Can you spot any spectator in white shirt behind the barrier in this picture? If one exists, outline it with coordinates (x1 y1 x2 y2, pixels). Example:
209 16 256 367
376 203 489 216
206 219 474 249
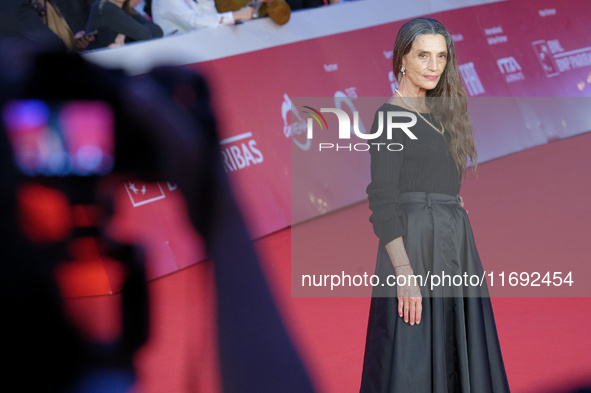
152 0 254 34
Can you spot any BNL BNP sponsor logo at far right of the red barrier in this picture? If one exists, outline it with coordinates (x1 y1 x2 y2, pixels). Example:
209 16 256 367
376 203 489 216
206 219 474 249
532 39 591 78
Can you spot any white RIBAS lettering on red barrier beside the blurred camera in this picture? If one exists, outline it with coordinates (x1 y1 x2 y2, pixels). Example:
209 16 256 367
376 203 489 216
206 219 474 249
220 132 264 172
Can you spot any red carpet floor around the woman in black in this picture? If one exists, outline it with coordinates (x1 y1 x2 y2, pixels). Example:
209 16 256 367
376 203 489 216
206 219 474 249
65 133 591 393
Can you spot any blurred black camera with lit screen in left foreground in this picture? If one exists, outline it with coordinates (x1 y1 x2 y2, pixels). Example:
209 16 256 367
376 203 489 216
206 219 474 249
0 48 190 392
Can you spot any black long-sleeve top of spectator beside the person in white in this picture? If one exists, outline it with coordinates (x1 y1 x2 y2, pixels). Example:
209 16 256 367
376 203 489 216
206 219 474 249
86 1 163 49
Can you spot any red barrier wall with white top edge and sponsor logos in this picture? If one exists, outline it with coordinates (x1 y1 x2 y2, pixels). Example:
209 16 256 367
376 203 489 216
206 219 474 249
72 0 591 295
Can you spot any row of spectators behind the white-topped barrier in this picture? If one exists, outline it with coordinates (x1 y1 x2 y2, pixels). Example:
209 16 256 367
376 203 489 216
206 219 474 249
0 0 350 52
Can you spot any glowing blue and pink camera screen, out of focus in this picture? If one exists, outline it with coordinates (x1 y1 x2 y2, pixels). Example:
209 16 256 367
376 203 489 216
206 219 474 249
2 100 114 176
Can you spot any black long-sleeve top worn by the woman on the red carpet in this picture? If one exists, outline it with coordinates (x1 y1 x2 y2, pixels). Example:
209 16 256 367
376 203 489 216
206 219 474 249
366 104 461 245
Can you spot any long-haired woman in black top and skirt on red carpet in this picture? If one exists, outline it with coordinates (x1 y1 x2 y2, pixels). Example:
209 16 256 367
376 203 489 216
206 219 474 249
360 18 509 393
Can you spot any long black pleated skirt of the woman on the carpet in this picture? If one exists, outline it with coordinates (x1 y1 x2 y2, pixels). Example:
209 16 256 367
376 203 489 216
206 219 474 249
360 192 509 393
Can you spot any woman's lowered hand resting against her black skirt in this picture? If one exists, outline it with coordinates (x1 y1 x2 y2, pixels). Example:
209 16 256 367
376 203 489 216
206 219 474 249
394 265 423 326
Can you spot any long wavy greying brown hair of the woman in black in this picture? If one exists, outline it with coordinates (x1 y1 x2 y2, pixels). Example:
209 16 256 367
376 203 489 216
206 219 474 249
392 18 478 177
